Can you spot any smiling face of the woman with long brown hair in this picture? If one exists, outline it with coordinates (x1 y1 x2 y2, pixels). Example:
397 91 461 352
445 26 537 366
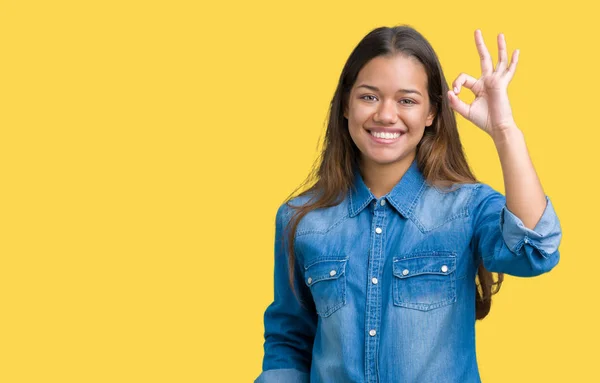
344 55 435 171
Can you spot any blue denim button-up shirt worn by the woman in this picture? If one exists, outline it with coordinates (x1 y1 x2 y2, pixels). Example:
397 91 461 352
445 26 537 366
255 162 562 383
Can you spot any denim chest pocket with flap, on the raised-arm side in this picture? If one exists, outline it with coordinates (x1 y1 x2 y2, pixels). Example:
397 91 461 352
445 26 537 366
392 251 456 311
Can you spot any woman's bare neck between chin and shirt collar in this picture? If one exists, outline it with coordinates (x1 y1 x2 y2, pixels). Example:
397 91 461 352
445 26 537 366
359 154 415 198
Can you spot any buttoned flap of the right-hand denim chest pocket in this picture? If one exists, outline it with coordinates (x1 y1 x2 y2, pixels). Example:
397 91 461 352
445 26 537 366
393 252 456 278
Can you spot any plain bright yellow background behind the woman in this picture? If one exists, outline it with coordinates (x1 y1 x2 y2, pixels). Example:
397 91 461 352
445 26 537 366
0 0 600 383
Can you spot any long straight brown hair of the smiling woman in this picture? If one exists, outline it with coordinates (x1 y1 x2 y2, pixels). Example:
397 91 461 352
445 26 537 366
283 25 504 319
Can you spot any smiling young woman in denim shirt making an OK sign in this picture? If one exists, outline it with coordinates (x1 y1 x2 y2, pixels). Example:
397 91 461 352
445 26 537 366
256 26 561 383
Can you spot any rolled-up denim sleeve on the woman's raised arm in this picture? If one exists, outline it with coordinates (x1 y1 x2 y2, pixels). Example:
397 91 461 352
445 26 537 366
472 185 562 277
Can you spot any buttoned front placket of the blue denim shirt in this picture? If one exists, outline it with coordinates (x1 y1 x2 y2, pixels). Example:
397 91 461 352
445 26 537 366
365 198 387 383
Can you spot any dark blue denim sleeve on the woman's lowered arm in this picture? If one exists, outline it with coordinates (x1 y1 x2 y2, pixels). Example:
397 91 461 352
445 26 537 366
255 204 317 383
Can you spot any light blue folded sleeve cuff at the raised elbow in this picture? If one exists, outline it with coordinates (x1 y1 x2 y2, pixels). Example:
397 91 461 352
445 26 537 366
500 196 562 258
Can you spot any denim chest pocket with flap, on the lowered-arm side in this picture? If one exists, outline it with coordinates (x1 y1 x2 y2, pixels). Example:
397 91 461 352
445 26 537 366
304 258 348 317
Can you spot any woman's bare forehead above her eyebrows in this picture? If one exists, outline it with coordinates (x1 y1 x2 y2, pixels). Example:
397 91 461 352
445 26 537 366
354 54 427 94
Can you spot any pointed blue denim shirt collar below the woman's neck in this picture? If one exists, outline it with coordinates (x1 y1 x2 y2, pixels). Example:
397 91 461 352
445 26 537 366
348 159 426 217
